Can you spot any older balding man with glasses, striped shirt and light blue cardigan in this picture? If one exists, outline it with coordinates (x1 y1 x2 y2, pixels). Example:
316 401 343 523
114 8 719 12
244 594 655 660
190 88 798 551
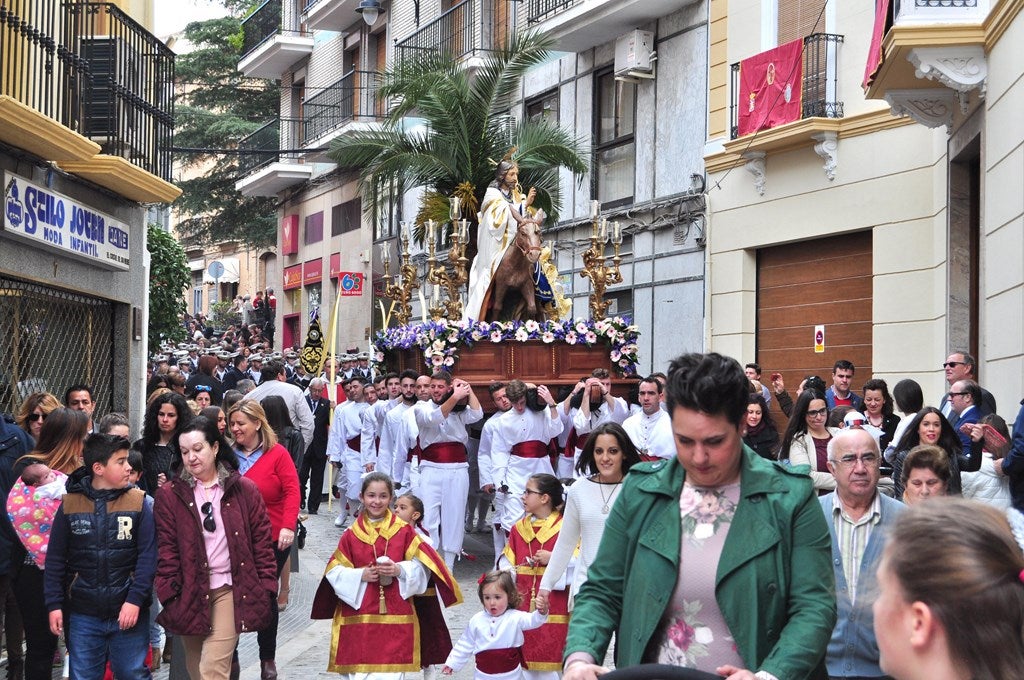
818 428 903 679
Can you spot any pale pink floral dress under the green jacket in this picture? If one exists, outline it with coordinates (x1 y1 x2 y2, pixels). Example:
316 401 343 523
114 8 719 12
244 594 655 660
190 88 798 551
645 482 744 673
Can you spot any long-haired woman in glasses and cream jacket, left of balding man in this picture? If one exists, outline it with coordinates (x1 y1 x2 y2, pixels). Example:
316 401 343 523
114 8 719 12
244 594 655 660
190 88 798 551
778 389 839 494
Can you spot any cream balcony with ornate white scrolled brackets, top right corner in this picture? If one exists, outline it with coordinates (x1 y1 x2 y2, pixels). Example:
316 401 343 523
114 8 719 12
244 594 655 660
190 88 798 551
863 0 991 127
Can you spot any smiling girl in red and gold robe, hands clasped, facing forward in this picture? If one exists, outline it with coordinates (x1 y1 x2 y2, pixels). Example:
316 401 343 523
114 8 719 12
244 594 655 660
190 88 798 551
311 472 462 680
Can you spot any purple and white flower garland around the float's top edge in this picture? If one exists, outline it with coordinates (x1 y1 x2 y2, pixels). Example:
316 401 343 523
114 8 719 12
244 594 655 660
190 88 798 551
374 316 640 375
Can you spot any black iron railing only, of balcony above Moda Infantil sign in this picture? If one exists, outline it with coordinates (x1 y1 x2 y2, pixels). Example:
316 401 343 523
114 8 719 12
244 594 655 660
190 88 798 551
0 0 174 180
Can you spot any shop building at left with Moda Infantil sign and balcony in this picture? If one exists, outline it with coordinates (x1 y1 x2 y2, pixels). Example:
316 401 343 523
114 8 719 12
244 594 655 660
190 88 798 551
0 0 179 425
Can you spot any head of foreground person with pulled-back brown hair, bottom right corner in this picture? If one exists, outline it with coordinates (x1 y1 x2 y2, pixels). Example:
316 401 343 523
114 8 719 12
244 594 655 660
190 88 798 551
873 499 1024 680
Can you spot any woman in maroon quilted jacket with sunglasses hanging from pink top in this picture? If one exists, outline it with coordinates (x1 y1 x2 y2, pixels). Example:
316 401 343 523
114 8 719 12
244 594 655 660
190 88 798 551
154 417 278 680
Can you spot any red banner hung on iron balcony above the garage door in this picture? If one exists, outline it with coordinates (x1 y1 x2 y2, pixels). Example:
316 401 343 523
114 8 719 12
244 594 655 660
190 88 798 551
737 39 804 136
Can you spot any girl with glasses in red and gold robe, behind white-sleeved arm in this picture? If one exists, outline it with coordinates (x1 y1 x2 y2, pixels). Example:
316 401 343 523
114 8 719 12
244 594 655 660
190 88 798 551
499 473 571 680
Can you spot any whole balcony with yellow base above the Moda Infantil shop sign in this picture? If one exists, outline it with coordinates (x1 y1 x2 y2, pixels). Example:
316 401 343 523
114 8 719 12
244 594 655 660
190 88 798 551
0 0 178 202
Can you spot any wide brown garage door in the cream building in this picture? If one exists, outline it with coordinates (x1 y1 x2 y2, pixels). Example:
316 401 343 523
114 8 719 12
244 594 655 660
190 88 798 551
757 231 871 427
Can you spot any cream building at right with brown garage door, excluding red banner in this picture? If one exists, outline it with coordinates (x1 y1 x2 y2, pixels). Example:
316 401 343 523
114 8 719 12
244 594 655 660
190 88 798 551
705 0 1024 416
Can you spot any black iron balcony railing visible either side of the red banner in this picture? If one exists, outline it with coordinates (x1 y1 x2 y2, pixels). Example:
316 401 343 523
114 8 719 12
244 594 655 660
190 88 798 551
729 33 843 139
